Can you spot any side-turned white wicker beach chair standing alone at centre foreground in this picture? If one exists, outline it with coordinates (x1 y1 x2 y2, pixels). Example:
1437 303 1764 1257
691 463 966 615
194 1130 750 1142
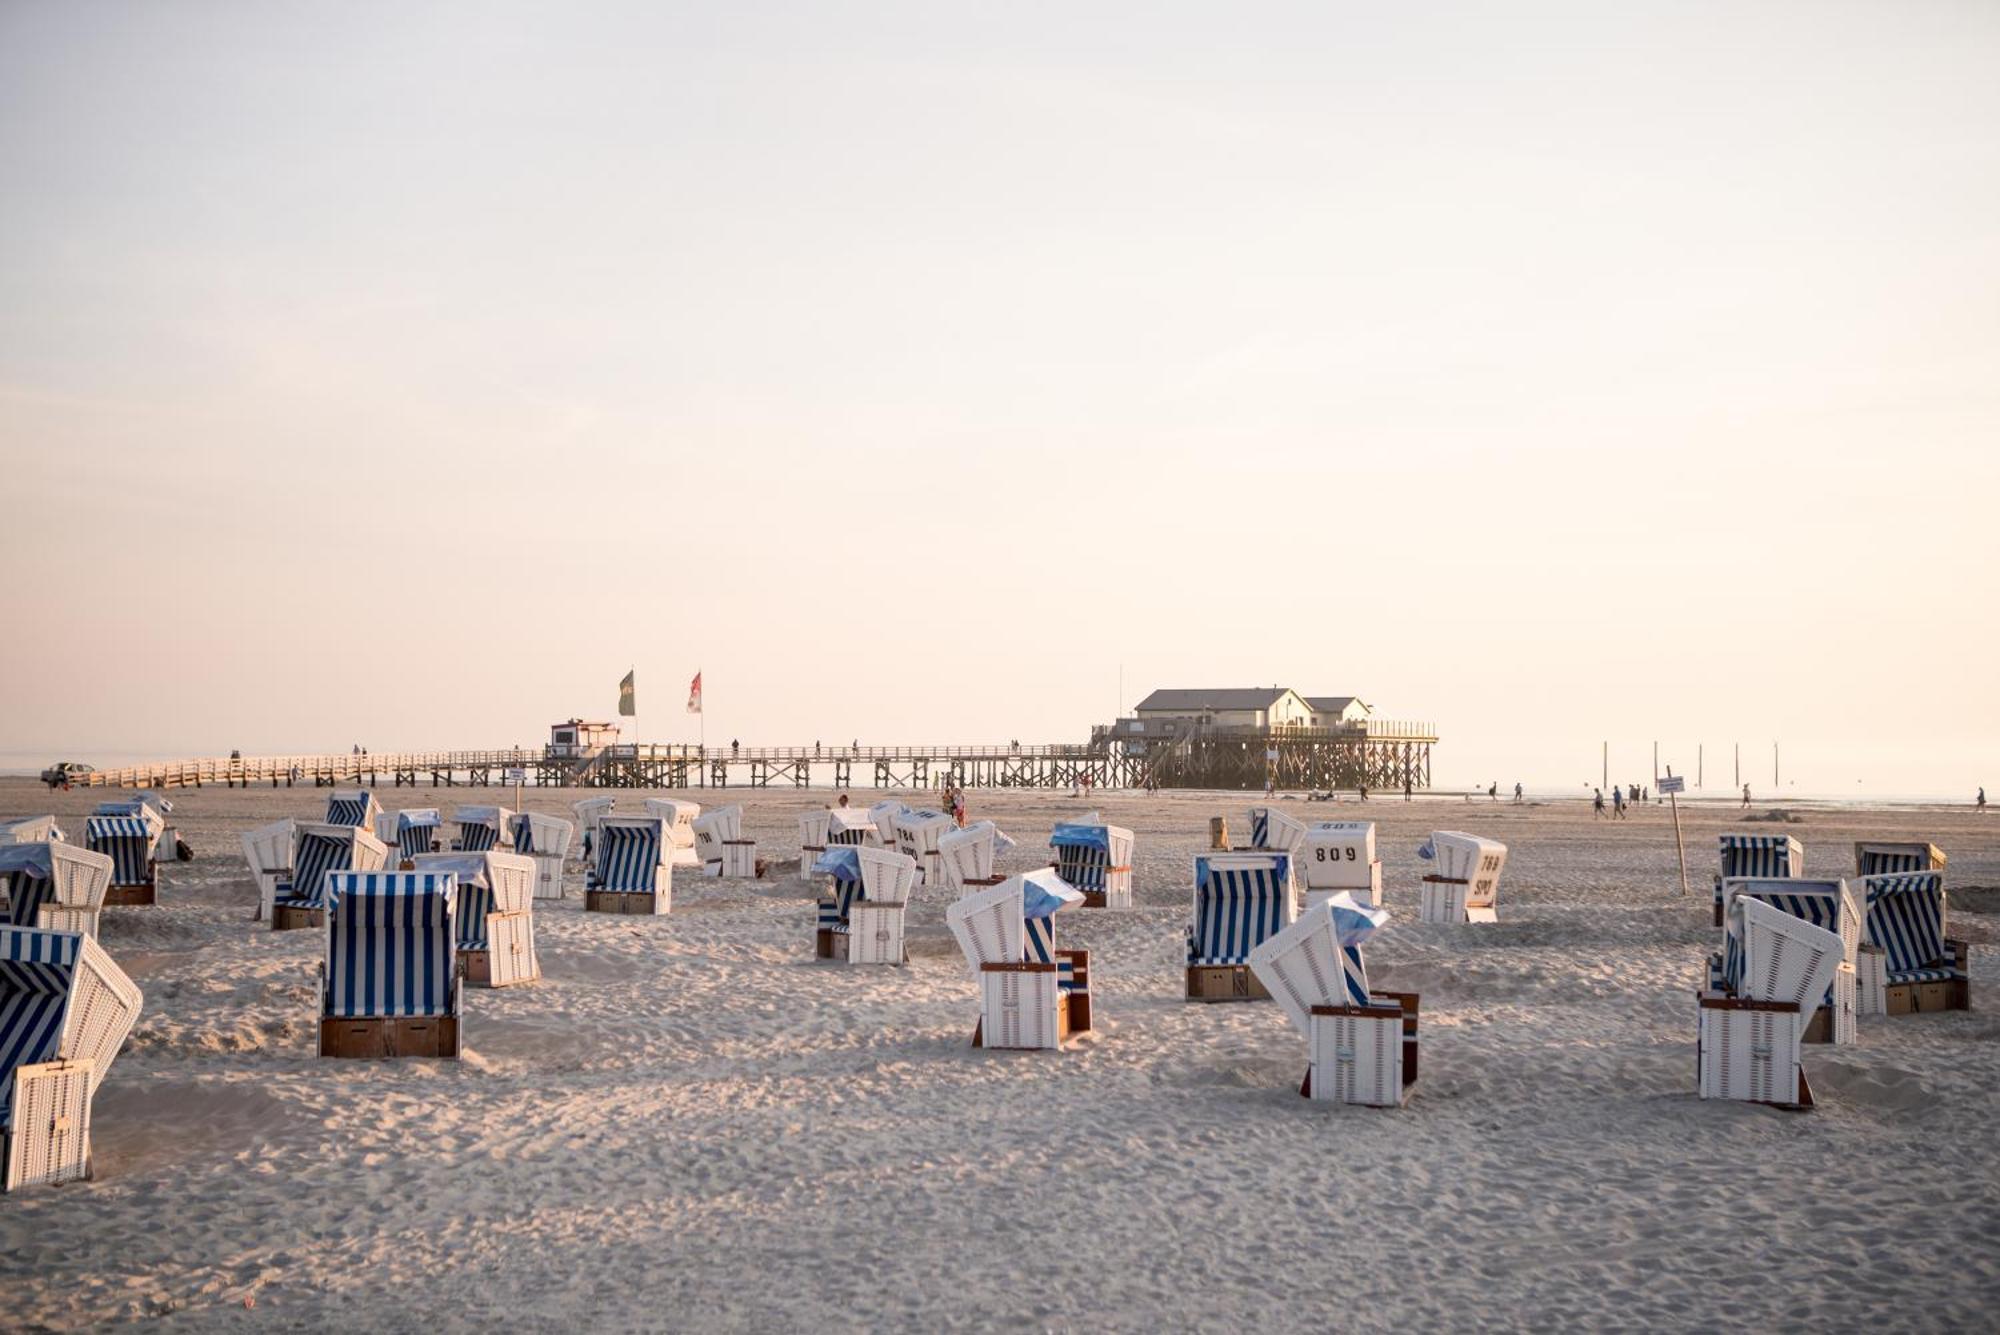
944 869 1090 1049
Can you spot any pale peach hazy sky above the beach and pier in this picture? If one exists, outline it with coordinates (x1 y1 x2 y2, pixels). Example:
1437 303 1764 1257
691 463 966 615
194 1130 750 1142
0 0 2000 795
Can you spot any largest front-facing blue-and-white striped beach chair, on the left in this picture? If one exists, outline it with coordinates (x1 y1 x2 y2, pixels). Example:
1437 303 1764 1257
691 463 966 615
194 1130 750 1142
320 871 460 1057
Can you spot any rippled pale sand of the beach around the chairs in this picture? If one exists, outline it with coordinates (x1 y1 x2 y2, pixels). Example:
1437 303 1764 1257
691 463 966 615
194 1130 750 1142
0 779 2000 1331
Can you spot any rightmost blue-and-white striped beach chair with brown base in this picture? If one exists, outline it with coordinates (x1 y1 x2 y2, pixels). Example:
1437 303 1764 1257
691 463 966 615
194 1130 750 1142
1858 871 1972 1015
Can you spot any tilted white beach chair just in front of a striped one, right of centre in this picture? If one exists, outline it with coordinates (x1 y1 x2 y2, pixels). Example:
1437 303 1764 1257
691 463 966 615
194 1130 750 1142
1250 889 1420 1107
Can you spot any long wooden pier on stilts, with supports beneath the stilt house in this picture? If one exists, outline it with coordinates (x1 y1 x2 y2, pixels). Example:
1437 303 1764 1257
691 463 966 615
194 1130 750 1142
74 729 1436 789
